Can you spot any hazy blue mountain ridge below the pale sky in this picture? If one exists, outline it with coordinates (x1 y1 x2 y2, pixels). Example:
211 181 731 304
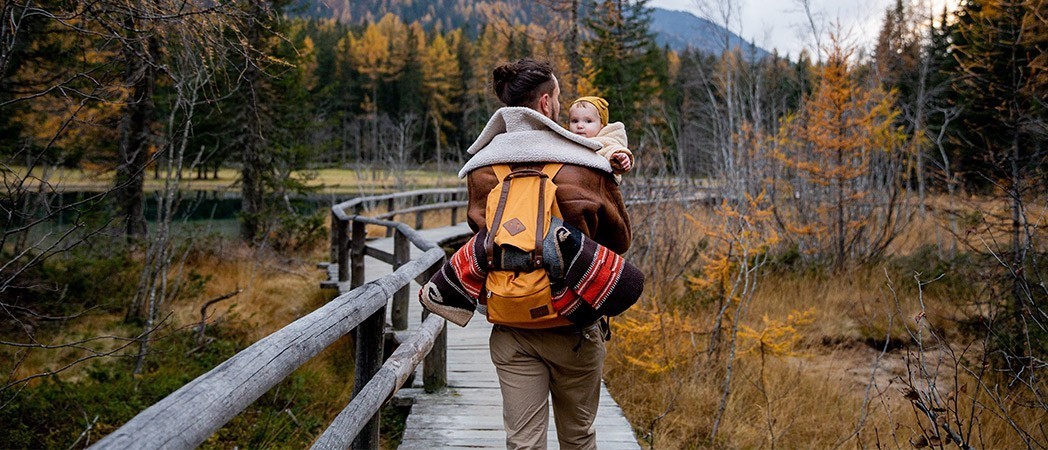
651 7 771 60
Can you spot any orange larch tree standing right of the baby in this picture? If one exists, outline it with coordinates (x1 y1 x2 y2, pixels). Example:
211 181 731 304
773 39 904 269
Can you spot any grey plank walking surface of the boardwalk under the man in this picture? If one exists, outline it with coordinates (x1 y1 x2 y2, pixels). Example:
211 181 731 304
354 223 640 450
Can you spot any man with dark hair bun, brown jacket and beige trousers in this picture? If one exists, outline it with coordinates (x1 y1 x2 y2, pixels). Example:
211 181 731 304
459 59 631 449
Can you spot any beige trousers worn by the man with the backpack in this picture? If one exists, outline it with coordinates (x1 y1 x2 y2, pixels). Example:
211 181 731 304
489 324 605 450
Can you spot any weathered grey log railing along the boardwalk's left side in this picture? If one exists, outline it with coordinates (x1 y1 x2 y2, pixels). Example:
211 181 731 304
91 189 465 449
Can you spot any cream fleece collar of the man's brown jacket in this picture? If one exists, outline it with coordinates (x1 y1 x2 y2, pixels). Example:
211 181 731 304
459 106 611 178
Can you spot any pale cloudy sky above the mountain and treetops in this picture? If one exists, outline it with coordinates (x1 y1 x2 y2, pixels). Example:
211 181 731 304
648 0 956 59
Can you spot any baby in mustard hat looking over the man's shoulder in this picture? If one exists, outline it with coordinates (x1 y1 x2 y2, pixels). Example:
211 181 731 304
568 97 633 183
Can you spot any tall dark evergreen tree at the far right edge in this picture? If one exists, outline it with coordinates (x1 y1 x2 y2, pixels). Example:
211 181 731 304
953 0 1048 369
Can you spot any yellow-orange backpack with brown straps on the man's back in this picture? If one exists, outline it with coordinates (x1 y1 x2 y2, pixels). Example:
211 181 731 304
480 164 571 328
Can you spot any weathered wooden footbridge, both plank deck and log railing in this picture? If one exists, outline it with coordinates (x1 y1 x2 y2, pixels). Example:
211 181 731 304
91 182 704 449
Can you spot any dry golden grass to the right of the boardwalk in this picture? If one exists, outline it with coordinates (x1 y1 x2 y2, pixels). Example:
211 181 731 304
606 191 1048 449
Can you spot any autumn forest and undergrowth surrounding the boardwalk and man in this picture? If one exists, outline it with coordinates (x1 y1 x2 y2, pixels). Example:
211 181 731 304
0 0 1048 449
